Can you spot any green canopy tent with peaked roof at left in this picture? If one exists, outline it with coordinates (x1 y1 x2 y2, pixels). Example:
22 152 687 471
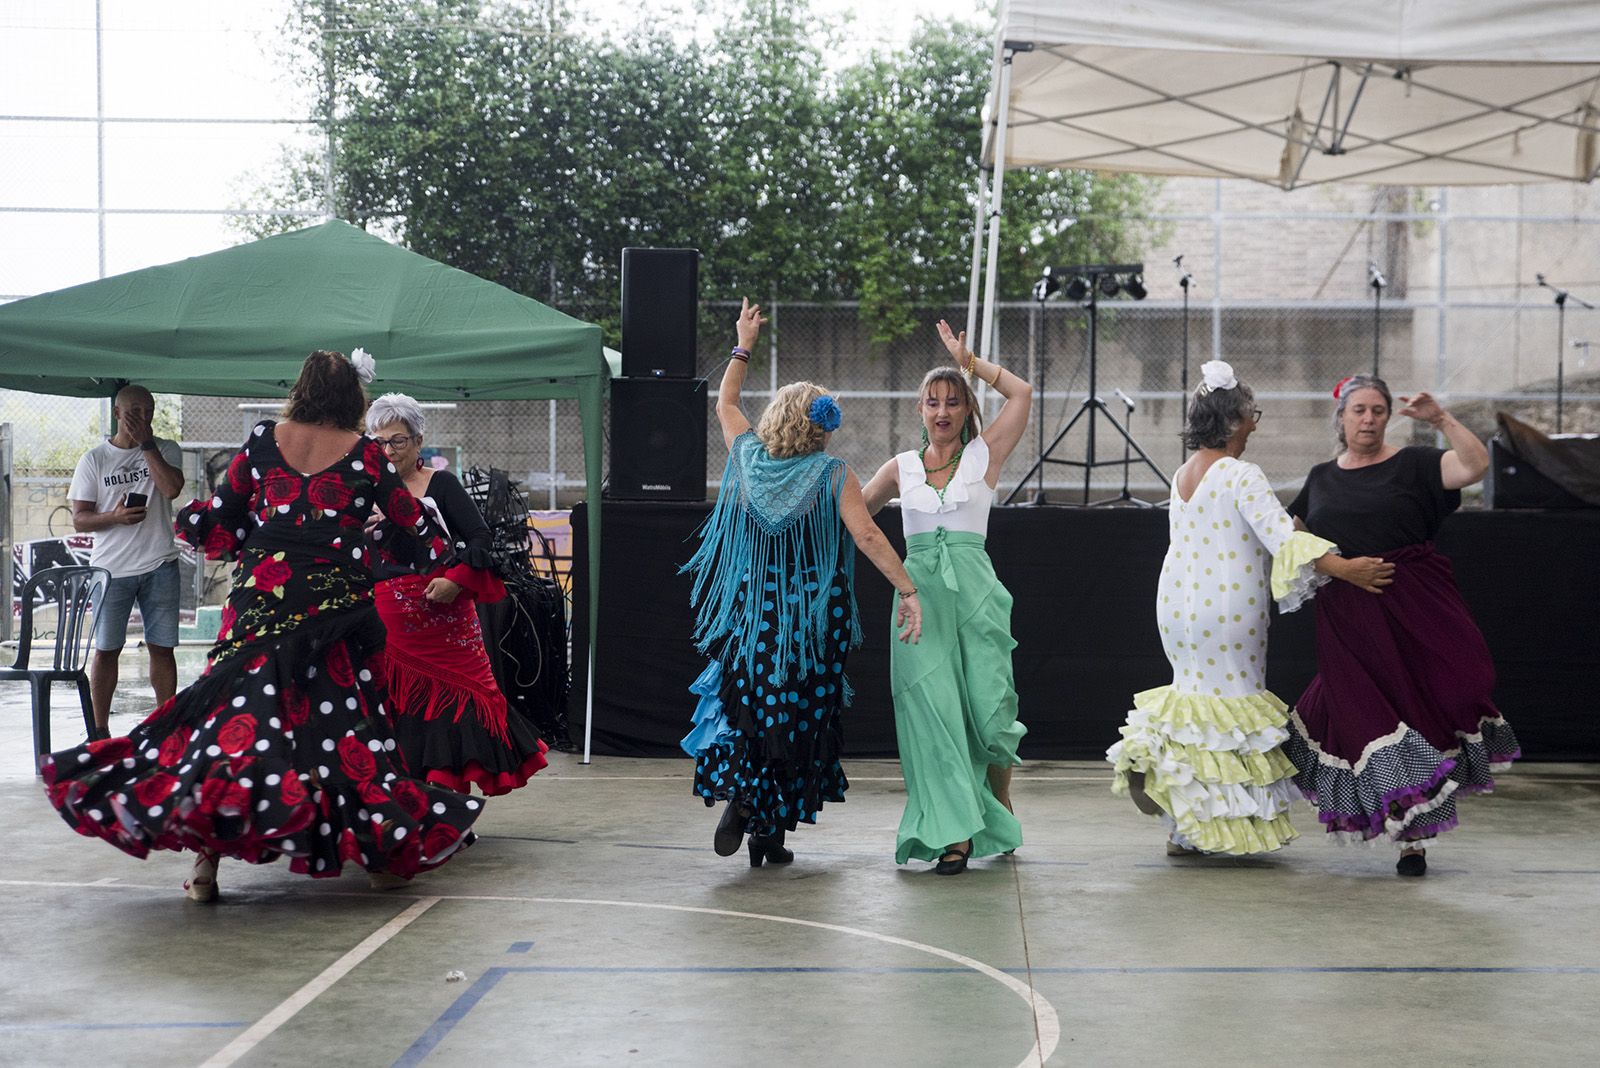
0 222 611 761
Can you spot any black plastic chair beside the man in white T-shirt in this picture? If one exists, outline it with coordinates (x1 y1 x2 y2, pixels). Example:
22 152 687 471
0 564 110 756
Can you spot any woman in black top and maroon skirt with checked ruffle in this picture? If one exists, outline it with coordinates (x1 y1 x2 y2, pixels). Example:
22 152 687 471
1283 374 1522 876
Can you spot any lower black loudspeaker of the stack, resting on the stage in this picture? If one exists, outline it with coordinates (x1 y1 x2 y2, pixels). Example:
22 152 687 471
606 379 706 500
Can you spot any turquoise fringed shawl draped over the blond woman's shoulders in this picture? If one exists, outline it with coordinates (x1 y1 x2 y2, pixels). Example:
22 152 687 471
682 430 861 678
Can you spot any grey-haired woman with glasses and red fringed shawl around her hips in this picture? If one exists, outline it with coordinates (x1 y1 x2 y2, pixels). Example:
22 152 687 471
366 393 546 795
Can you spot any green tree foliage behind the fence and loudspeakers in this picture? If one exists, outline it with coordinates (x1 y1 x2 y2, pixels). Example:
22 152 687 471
254 0 1150 341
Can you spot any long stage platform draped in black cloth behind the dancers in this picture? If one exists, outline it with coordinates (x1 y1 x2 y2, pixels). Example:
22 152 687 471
571 500 1600 761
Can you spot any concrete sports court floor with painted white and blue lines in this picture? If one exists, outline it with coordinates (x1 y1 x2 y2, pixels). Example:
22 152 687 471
0 651 1600 1068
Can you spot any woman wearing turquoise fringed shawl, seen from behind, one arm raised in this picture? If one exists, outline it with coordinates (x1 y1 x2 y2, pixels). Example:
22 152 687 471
683 299 922 868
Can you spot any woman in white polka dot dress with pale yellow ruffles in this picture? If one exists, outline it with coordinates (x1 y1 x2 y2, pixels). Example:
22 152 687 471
1106 360 1394 855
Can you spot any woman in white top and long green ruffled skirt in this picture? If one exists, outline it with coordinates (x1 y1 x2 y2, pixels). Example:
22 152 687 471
862 320 1034 875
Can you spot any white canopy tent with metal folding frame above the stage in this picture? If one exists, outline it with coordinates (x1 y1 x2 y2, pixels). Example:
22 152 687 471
968 0 1600 352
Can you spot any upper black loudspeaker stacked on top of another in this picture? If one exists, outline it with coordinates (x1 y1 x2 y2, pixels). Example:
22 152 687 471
622 248 699 379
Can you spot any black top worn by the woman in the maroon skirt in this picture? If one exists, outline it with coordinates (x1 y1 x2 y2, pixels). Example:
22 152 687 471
1290 444 1461 556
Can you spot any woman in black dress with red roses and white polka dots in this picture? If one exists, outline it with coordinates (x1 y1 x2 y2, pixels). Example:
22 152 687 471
43 350 483 900
